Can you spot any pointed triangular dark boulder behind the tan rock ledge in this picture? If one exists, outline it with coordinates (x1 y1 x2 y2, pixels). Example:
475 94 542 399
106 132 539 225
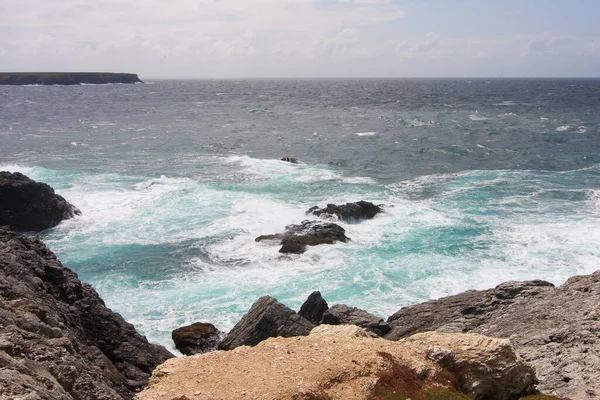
219 296 314 350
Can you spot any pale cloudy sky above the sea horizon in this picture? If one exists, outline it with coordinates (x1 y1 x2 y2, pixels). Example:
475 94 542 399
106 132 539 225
0 0 600 79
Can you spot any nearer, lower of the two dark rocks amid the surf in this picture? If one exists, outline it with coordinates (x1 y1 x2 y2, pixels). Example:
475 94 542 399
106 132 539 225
255 221 350 254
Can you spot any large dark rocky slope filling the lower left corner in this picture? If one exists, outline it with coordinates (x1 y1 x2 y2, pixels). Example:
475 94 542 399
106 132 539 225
0 230 173 400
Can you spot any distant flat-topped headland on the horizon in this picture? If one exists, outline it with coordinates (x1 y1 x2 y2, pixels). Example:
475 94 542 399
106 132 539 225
0 72 142 85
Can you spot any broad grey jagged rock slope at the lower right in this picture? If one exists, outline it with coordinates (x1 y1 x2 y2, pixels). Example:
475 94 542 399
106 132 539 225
386 271 600 400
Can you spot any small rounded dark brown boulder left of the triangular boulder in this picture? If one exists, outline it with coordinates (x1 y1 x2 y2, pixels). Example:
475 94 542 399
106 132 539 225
171 322 221 356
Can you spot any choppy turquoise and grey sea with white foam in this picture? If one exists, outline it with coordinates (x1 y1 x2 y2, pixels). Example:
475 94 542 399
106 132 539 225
0 79 600 349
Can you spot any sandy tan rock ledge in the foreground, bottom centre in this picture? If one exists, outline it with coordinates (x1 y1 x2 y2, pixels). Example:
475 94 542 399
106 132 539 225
136 325 535 400
